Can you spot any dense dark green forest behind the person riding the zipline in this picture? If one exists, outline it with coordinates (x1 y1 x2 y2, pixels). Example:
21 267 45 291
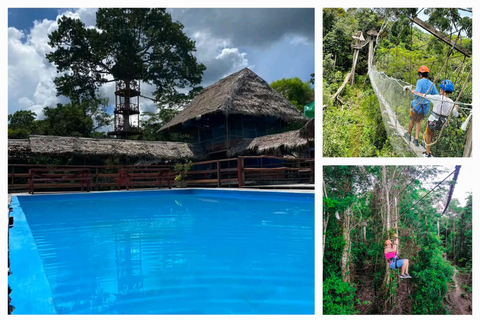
322 166 472 315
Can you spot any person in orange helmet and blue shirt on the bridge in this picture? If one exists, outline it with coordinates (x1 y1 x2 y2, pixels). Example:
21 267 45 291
405 66 438 147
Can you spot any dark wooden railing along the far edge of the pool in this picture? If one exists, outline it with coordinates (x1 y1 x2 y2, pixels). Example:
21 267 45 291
8 156 315 193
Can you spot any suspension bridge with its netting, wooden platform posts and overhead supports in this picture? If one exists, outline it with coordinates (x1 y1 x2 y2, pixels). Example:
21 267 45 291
338 18 472 157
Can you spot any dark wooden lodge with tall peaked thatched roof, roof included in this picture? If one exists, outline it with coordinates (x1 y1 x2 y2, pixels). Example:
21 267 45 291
160 68 308 159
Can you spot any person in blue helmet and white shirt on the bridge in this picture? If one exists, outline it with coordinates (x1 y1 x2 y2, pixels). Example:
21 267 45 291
410 79 458 158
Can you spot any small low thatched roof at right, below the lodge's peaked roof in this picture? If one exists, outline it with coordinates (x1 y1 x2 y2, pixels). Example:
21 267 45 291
227 129 309 157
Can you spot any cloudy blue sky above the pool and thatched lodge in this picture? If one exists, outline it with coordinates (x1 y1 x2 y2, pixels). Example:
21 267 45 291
8 8 315 119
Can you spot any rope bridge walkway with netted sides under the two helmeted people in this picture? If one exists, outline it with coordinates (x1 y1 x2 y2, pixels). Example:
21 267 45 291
368 32 472 157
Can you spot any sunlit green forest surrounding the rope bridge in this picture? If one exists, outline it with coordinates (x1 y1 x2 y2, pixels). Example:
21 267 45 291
322 8 472 157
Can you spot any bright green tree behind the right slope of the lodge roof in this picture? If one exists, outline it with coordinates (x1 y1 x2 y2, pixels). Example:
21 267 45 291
270 77 315 112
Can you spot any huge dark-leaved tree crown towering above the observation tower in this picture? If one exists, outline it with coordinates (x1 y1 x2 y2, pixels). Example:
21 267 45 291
46 8 205 110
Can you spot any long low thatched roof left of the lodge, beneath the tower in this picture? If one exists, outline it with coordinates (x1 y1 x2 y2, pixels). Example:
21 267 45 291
8 136 207 160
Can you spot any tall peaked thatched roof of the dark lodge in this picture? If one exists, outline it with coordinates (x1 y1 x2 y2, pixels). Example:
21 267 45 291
160 68 307 130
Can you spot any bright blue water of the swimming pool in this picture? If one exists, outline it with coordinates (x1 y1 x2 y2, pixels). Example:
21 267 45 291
9 190 314 314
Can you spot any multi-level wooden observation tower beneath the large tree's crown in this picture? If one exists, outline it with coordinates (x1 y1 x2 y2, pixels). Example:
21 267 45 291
108 80 141 139
